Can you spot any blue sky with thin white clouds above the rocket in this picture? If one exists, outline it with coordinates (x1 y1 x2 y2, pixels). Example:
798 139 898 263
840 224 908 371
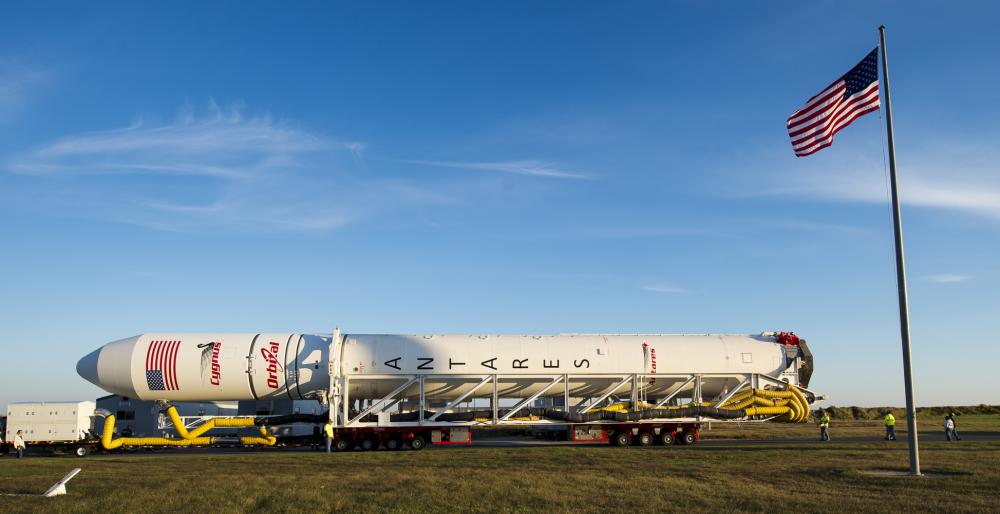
0 2 1000 405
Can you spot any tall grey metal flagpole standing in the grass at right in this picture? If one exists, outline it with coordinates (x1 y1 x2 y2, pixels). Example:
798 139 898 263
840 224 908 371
878 25 920 475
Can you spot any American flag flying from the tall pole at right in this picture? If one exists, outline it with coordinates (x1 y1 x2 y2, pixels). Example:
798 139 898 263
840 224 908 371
788 48 879 157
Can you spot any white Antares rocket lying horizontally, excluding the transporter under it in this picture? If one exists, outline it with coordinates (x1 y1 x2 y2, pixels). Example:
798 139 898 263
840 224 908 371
77 333 789 401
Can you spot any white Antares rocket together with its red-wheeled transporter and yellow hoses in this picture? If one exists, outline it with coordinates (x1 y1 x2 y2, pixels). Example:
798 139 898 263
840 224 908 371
77 330 817 449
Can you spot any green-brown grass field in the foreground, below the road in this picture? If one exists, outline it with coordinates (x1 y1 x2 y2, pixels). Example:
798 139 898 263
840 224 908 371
0 434 1000 513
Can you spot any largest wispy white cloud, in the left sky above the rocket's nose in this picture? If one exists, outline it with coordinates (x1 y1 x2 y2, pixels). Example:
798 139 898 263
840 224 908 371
0 102 449 231
